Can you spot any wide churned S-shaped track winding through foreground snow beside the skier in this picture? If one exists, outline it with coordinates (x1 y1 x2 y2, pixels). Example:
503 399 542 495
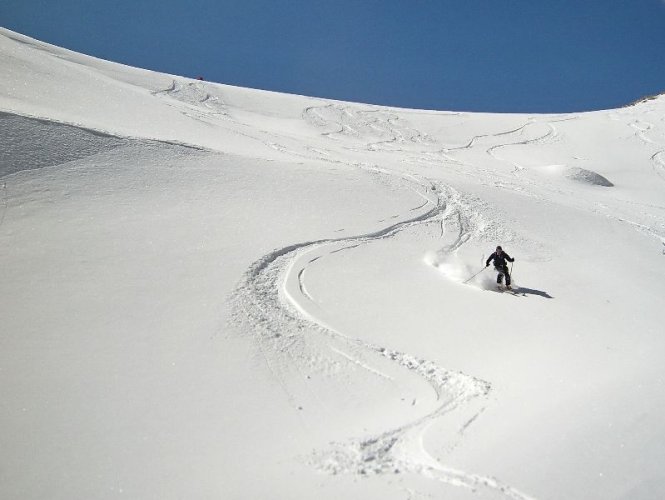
230 172 530 500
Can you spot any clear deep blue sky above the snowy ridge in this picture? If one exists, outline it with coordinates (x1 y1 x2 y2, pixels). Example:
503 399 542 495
0 0 665 112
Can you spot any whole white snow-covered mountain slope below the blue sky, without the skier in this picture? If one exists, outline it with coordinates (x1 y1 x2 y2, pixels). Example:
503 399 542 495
0 30 665 499
